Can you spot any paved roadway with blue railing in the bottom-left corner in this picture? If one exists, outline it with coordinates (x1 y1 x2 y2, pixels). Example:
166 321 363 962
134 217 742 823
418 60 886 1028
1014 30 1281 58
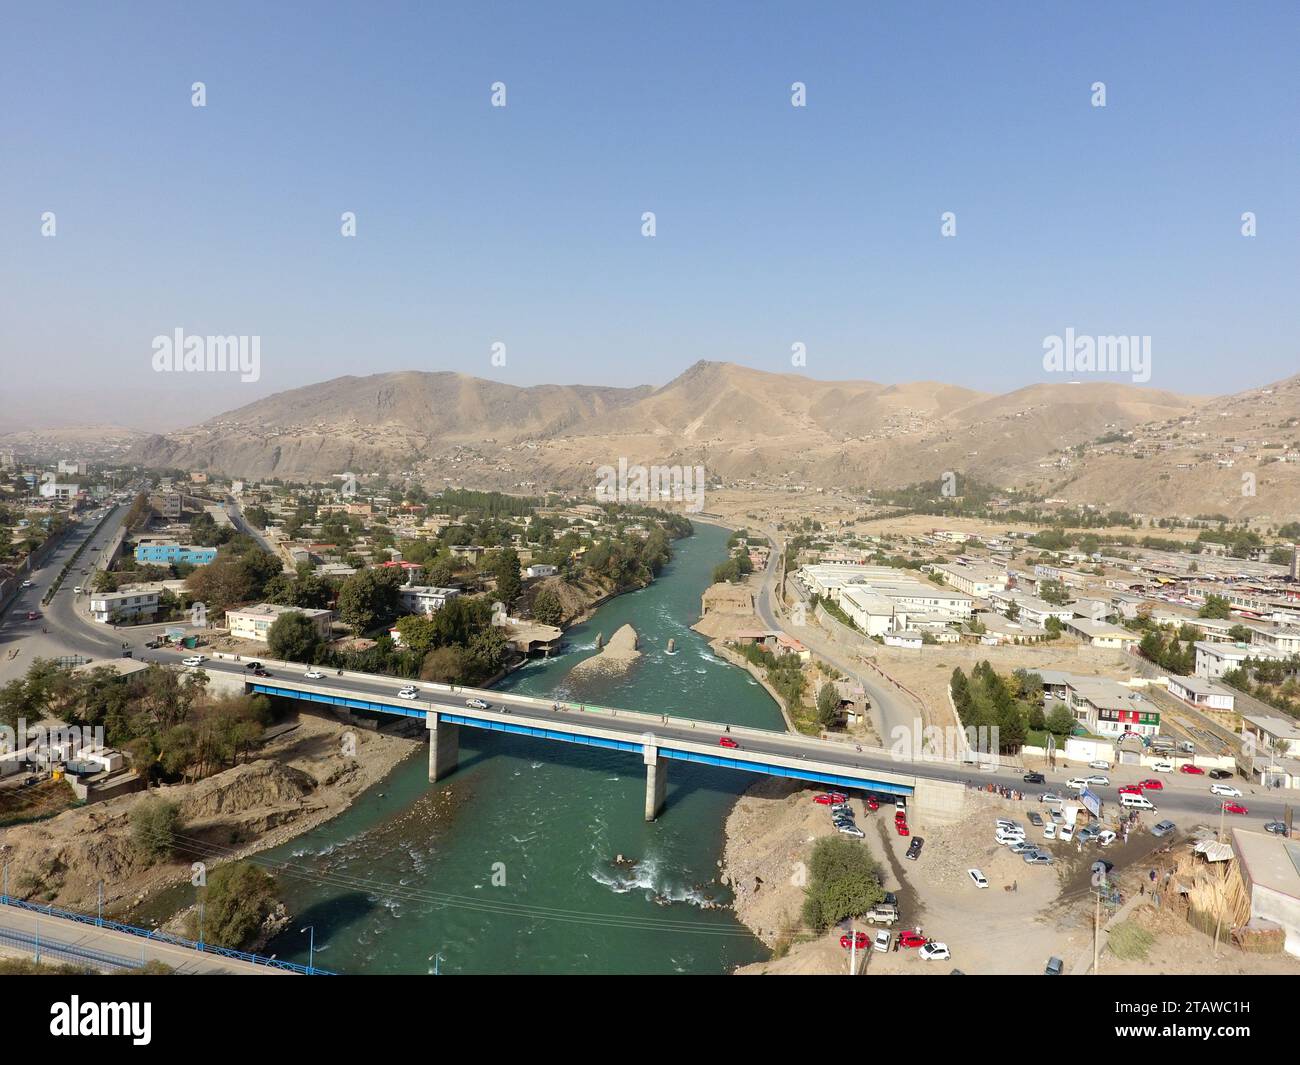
0 905 284 977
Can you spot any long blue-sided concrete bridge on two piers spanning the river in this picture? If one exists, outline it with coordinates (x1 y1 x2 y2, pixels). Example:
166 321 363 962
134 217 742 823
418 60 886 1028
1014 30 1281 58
169 654 972 821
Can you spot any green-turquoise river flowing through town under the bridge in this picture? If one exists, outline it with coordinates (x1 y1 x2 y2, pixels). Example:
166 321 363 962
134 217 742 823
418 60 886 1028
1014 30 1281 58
263 523 783 974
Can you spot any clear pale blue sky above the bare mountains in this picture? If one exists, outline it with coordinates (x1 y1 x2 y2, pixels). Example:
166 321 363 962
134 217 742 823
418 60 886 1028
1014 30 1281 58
0 1 1300 428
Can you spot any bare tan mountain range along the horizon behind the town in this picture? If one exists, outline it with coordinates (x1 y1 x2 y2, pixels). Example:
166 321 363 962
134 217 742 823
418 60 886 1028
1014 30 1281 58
133 362 1300 514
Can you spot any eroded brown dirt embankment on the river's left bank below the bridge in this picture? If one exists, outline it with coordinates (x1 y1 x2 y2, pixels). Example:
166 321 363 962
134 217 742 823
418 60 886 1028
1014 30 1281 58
0 715 419 912
